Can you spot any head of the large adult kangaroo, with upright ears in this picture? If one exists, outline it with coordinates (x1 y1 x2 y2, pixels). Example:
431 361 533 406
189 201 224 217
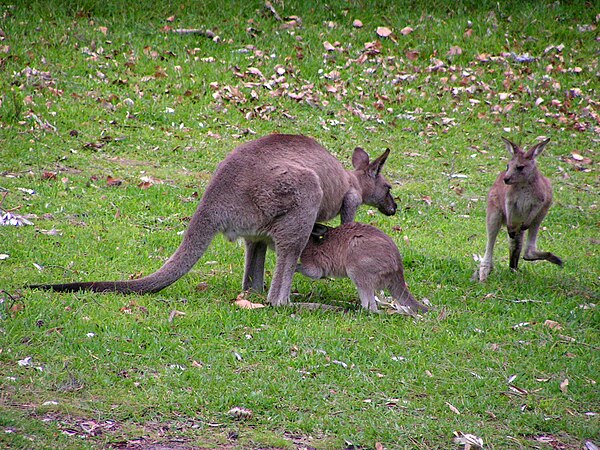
352 147 397 216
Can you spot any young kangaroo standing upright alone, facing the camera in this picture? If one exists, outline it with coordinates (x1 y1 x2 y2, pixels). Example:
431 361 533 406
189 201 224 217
479 138 562 281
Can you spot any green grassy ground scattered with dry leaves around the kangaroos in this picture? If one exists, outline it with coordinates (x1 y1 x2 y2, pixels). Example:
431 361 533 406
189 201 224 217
0 0 600 449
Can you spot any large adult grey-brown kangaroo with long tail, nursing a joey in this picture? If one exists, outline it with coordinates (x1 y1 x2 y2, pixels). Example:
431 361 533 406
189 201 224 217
31 134 396 306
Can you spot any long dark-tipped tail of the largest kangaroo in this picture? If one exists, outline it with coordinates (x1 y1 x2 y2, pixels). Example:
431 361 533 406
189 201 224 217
29 212 218 294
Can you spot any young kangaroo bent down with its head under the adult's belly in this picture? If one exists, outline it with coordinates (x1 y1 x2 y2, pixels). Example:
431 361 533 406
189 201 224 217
298 222 428 312
